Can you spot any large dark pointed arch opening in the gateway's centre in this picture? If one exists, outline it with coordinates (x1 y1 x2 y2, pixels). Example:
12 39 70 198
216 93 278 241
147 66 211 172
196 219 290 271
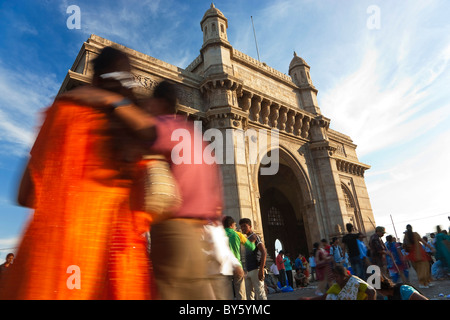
256 146 318 259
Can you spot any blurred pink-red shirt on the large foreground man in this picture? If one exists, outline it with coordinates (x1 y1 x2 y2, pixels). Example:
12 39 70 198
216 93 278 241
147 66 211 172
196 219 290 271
151 115 223 219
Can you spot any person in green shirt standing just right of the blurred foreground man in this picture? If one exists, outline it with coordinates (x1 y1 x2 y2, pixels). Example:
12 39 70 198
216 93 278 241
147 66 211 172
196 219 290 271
222 216 256 300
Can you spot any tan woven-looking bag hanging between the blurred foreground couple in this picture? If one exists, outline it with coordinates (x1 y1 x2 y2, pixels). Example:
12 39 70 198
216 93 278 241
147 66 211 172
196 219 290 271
130 155 182 222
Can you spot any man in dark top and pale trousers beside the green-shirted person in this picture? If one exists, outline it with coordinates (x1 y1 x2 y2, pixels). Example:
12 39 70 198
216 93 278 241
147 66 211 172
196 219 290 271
239 218 267 300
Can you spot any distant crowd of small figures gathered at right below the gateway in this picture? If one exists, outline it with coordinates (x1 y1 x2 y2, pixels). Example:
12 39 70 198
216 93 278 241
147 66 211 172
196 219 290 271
262 223 450 300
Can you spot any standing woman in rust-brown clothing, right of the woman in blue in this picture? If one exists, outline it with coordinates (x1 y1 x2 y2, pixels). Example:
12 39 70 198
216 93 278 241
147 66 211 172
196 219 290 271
403 224 431 288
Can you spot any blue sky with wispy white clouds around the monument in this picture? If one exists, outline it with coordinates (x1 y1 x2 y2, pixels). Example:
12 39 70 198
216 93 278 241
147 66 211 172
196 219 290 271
0 0 450 258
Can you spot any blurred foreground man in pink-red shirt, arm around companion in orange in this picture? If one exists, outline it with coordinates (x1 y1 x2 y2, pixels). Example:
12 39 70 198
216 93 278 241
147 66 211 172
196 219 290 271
74 80 223 300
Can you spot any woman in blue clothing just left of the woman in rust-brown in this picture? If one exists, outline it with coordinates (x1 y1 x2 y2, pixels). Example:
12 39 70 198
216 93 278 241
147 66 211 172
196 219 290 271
386 235 409 283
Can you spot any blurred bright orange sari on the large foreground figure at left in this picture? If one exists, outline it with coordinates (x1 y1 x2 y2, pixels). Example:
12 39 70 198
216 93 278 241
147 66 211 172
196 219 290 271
0 99 155 300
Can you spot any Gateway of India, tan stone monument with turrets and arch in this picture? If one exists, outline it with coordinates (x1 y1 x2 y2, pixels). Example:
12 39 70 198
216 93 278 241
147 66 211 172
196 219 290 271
60 4 375 257
